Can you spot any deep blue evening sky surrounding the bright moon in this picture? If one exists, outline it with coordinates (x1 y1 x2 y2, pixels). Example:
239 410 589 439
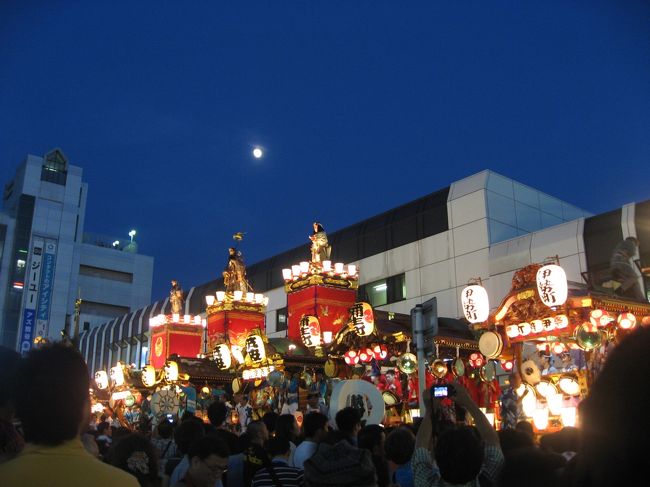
0 0 650 299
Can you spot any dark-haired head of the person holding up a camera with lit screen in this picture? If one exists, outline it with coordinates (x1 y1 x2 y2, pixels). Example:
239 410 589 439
435 426 483 484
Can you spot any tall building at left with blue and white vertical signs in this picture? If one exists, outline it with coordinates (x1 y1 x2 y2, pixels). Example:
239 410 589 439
0 149 153 351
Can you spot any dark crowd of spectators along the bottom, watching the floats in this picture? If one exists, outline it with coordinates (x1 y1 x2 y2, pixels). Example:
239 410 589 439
0 328 650 487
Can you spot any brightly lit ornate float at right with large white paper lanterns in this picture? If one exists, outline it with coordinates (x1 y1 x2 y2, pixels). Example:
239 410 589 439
461 258 650 433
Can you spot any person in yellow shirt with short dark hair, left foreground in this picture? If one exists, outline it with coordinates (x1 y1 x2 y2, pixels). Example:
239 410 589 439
0 344 139 487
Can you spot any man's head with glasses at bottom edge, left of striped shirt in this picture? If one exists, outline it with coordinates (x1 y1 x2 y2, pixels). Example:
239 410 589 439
188 436 230 487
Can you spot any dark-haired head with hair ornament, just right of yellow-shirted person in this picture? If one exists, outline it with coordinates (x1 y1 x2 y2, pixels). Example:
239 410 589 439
108 433 158 487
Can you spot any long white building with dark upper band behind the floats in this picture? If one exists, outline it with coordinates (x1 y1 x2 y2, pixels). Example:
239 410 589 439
81 171 650 370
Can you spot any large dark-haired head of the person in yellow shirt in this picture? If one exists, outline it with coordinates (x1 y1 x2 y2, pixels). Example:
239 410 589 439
15 344 90 446
